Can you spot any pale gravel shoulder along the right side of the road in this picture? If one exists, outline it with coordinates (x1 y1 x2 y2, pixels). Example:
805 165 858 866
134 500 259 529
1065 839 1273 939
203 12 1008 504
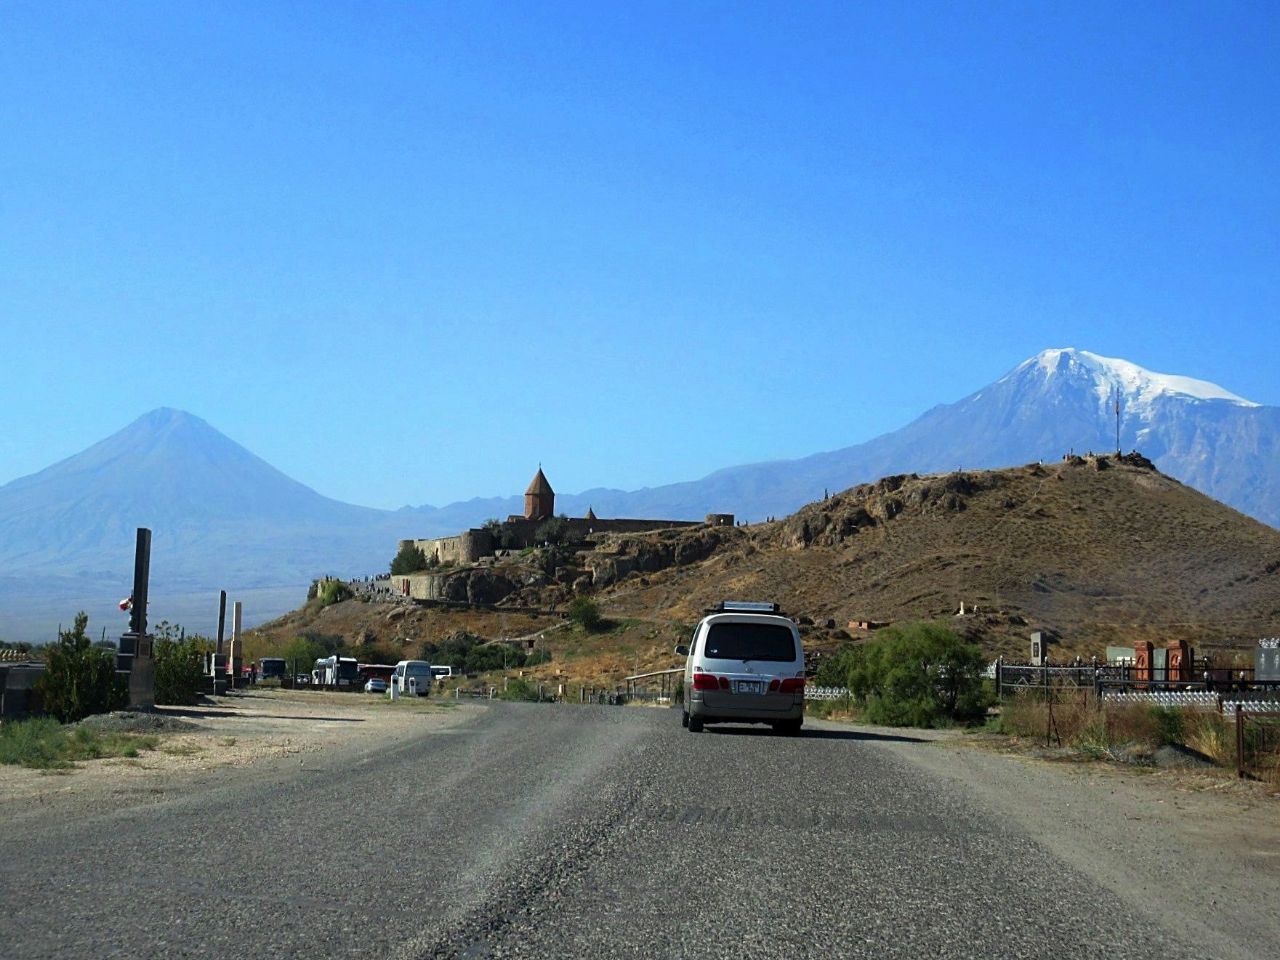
812 721 1280 960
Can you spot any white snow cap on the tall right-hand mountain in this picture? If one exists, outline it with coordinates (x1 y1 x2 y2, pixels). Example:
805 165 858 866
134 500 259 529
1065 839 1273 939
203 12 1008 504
1005 347 1260 407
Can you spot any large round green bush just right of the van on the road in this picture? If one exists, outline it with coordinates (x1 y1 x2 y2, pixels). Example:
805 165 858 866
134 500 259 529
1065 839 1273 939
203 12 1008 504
826 623 989 727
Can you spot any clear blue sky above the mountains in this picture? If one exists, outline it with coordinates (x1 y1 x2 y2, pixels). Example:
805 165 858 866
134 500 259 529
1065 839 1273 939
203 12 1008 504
0 0 1280 507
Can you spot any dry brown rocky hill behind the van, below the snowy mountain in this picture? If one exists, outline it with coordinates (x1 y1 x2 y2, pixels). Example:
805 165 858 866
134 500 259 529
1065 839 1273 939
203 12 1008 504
247 454 1280 664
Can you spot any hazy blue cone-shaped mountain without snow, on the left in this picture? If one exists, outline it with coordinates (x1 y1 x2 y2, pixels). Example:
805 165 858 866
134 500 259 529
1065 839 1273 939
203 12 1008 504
0 408 398 639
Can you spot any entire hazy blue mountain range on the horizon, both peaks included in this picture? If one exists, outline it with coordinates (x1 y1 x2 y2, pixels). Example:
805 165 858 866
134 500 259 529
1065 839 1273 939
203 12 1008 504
0 349 1280 639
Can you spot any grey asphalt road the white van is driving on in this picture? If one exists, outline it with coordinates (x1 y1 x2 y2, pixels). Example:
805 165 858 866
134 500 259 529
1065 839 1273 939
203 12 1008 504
0 704 1228 960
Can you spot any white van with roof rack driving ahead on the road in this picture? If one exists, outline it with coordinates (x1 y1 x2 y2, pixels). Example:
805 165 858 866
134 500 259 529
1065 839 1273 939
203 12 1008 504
676 600 804 736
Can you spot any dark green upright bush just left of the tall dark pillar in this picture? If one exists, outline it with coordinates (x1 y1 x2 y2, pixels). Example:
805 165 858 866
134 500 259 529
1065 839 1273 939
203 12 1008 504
36 611 129 723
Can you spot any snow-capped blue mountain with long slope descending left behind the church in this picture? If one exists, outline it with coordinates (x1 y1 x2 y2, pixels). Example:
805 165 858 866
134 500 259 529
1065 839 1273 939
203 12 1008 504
535 348 1280 526
